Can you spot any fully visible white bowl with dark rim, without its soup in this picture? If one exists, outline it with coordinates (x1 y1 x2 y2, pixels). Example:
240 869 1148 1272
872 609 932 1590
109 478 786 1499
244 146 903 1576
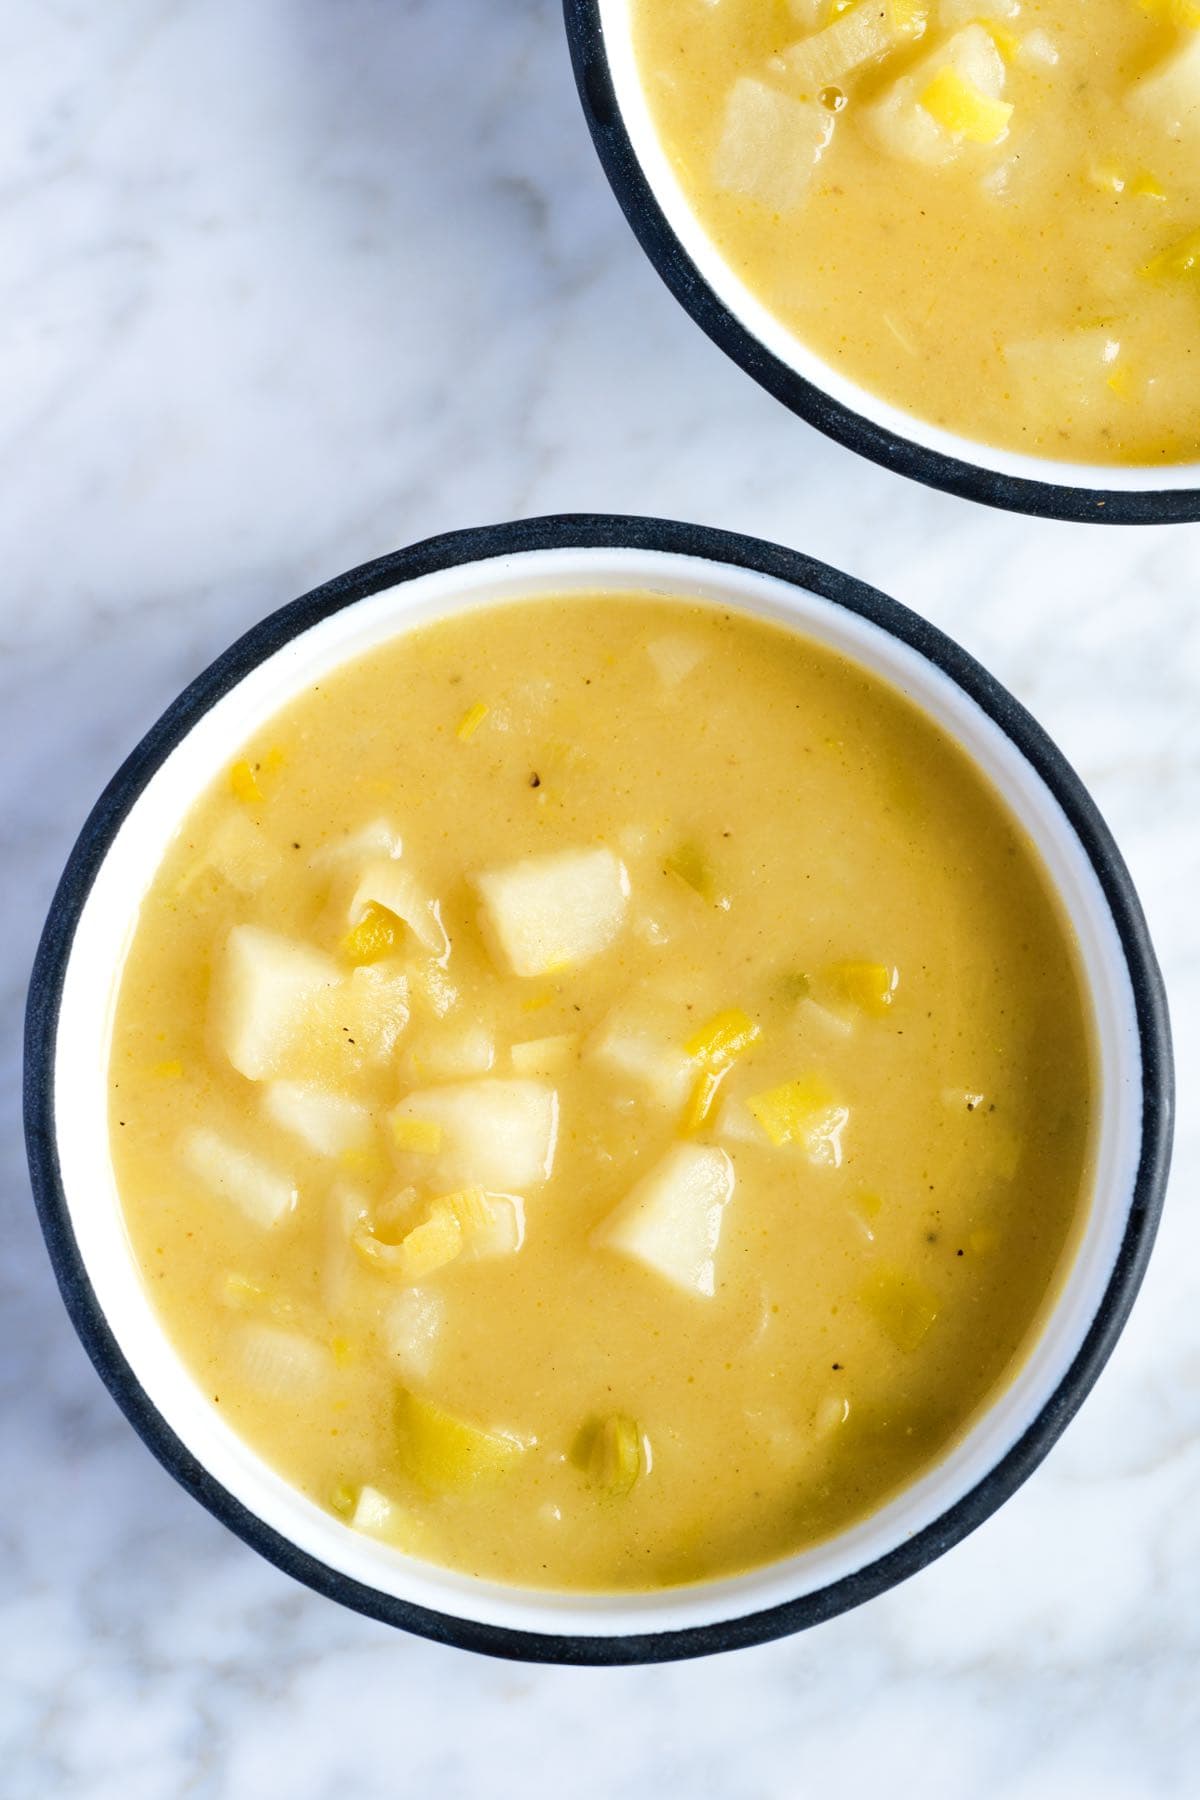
25 517 1171 1663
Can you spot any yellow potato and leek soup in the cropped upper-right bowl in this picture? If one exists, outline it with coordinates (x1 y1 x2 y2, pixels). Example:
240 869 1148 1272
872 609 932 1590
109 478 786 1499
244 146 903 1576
628 0 1200 464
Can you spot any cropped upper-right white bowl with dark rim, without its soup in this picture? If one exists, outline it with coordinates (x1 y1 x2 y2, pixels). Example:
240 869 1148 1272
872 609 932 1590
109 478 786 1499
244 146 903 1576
563 0 1200 526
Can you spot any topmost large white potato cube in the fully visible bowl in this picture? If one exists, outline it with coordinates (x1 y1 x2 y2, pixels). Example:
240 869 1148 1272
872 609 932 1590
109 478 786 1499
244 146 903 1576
475 846 630 976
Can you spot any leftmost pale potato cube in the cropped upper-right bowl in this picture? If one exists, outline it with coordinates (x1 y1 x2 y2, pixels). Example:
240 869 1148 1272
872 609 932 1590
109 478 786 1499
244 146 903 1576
712 76 835 214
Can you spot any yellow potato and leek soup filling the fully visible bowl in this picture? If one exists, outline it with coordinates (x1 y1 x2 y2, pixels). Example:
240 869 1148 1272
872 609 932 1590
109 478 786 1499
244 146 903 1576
110 594 1094 1591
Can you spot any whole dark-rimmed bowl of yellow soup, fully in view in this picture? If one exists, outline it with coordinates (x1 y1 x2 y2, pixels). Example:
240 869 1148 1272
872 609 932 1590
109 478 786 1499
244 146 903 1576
31 520 1169 1660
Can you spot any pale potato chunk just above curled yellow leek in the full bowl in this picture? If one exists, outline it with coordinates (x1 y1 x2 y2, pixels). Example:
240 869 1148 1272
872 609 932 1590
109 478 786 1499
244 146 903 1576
392 1080 558 1193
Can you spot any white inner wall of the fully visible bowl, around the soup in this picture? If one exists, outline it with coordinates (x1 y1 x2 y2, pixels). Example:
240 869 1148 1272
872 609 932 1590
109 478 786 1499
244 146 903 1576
54 549 1142 1636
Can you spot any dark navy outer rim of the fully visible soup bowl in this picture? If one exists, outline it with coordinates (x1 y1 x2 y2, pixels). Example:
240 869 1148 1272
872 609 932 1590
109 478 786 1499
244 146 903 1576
23 513 1173 1665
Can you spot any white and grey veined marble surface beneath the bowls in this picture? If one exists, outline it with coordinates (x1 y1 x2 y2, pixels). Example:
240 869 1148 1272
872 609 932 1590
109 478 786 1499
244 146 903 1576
0 0 1200 1800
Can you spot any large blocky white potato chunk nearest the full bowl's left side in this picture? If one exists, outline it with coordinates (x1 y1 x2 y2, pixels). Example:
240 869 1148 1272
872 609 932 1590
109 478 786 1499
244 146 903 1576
214 925 342 1082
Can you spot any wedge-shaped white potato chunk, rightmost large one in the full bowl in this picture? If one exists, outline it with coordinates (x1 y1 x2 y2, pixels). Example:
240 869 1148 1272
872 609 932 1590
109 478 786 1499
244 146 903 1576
592 1143 734 1294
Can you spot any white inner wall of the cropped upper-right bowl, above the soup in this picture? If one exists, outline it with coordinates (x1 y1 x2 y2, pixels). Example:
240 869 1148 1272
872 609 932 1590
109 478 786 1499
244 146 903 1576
596 0 1200 493
